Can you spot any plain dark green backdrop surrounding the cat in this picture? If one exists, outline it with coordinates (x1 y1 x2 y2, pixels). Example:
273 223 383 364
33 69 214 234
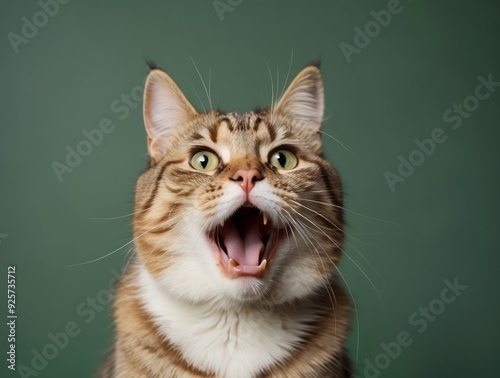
0 0 500 377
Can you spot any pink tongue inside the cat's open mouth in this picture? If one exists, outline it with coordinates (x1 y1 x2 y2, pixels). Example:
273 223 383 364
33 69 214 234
224 216 264 266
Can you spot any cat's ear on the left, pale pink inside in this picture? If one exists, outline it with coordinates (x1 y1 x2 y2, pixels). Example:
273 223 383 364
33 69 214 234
143 68 196 162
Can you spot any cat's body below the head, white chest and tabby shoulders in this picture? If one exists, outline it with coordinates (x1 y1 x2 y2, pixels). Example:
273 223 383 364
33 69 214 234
111 260 349 378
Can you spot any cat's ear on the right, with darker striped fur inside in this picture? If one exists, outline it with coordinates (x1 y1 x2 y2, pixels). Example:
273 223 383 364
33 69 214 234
273 66 325 130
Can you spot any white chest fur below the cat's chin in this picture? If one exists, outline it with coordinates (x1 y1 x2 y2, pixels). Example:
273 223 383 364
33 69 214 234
139 267 312 378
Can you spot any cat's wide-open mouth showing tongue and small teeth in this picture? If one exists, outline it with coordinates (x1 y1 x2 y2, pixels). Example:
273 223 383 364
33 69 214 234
208 207 278 278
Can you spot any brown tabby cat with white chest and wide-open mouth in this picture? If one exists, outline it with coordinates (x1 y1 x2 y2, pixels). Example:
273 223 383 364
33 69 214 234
99 65 353 378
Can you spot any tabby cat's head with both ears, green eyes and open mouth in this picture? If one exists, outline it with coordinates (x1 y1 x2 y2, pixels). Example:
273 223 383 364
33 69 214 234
134 66 343 303
